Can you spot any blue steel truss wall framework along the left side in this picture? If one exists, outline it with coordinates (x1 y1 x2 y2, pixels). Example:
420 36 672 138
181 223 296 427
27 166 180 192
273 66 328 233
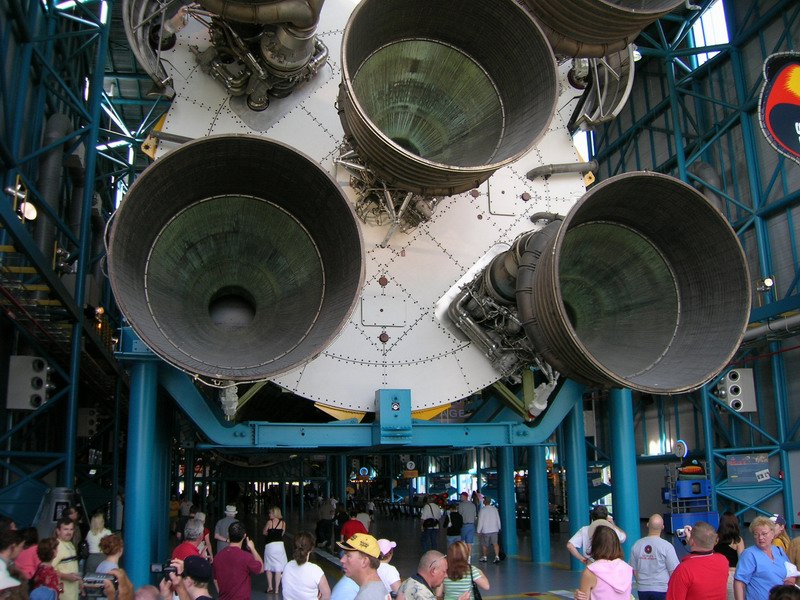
0 0 129 522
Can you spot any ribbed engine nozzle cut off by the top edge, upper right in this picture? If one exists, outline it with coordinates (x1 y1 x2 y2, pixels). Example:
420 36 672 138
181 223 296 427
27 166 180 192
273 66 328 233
524 0 684 58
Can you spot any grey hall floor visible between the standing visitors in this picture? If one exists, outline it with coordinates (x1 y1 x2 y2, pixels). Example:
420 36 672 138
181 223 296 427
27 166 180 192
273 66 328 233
207 511 648 600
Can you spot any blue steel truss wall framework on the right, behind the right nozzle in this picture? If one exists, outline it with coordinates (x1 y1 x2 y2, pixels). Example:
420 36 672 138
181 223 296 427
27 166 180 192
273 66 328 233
592 0 800 517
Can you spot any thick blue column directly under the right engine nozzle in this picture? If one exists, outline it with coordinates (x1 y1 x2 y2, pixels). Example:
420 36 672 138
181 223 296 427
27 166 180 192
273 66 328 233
608 388 641 556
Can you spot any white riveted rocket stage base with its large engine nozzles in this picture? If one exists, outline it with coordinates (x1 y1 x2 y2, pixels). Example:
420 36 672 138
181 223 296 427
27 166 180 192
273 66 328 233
108 0 750 411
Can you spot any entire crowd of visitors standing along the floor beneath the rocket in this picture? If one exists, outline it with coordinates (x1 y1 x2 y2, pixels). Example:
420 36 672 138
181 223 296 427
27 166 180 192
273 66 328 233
0 492 800 600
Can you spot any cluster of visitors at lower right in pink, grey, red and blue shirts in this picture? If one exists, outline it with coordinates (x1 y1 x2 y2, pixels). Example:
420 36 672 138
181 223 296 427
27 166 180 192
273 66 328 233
567 506 800 600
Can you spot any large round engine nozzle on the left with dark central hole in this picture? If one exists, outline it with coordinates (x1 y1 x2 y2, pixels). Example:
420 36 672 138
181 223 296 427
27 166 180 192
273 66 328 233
108 135 364 381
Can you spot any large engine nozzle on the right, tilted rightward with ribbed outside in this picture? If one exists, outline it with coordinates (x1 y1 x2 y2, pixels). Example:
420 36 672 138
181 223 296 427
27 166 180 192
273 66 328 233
516 172 750 394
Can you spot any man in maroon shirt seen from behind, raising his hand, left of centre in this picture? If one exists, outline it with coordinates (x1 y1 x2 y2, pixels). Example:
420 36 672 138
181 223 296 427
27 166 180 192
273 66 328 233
214 521 264 600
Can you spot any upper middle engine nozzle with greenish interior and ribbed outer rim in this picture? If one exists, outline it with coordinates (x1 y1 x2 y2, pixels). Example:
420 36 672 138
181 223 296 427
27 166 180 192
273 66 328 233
338 0 558 195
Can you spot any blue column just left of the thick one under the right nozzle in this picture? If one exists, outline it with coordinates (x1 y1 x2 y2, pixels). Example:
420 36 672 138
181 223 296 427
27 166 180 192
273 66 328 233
561 402 589 571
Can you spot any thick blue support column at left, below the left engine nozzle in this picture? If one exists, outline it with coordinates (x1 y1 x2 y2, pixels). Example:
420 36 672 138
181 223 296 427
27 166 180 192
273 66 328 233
124 361 158 588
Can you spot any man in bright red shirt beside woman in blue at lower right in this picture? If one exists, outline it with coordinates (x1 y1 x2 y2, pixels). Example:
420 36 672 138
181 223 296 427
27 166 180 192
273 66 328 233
667 521 728 600
